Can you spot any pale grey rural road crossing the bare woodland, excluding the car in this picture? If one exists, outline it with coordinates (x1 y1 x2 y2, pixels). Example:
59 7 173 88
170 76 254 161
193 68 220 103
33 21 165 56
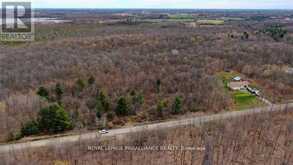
0 103 293 153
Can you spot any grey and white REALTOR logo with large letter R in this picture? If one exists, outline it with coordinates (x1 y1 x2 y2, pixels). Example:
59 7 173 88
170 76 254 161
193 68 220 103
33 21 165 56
0 1 34 41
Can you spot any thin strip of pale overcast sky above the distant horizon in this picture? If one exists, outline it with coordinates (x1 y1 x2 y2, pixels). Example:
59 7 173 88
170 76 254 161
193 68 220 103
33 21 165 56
25 0 293 9
